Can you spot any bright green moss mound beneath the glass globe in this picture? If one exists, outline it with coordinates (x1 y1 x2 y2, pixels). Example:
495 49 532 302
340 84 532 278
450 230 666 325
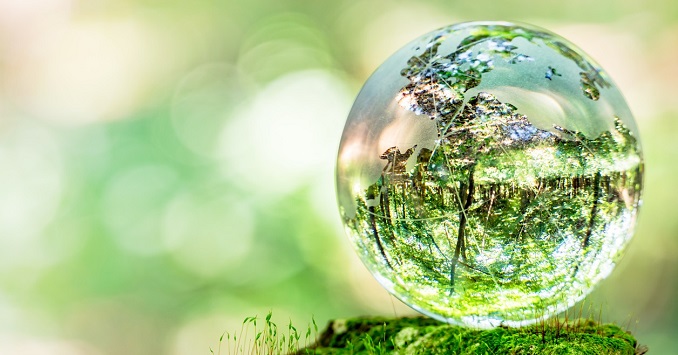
299 317 647 355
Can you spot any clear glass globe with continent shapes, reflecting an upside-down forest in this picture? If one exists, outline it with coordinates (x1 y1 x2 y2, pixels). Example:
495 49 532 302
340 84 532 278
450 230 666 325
336 22 643 328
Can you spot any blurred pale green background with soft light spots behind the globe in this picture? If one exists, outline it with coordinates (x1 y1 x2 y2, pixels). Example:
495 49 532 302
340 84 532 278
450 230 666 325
0 0 678 355
